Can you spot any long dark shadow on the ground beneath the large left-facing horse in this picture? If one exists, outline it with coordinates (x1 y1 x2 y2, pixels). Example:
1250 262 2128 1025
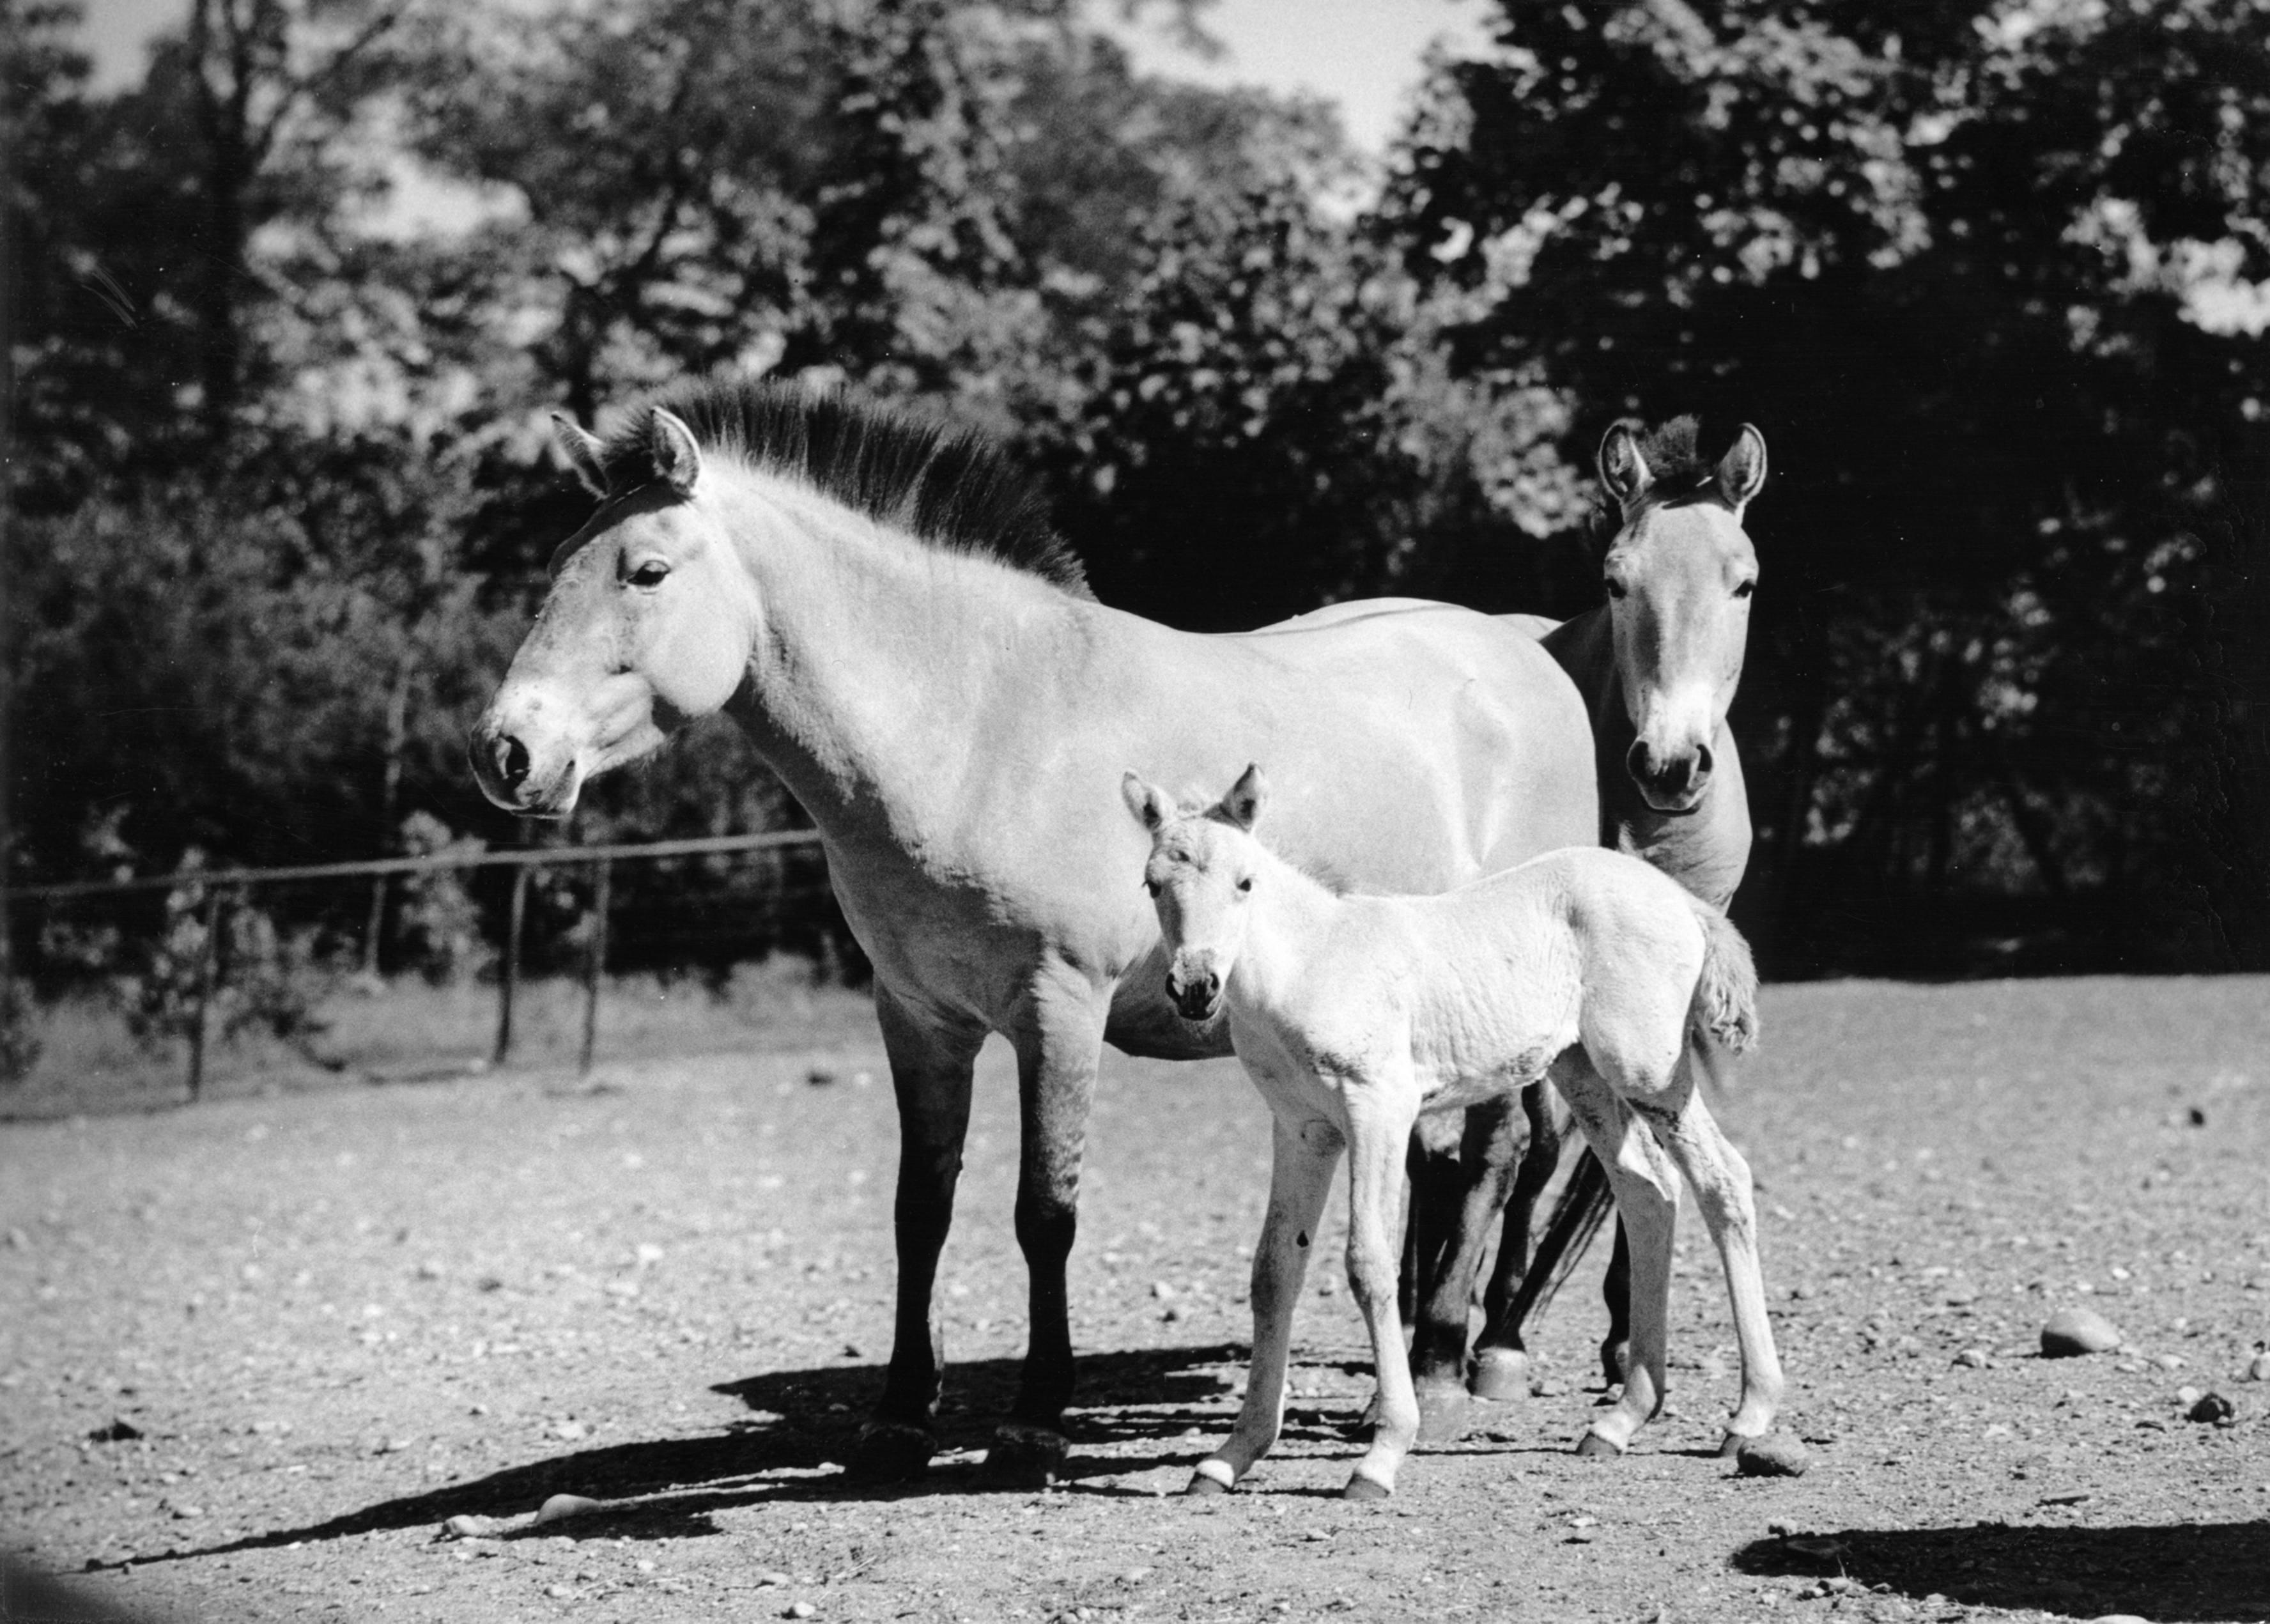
97 1342 1246 1565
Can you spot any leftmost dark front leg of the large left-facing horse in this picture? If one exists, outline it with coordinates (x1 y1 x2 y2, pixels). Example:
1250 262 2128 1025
851 984 985 1483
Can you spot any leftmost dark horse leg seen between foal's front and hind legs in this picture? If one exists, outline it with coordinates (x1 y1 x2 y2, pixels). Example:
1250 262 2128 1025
1412 1099 1521 1442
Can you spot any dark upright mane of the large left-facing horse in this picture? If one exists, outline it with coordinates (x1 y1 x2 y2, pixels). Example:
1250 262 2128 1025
599 382 1092 598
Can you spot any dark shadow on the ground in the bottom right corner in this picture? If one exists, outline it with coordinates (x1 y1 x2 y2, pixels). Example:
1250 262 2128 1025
1734 1522 2270 1620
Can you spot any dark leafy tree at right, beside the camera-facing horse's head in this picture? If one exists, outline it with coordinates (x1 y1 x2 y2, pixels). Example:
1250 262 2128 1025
1382 0 2270 956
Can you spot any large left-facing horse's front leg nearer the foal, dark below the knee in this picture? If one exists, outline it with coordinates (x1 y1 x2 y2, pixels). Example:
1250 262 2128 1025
985 975 1108 1485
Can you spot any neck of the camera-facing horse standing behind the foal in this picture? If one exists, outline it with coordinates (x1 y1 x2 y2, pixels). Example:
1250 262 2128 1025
1543 604 1750 906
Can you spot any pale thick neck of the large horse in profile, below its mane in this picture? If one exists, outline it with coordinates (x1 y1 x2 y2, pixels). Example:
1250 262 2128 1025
724 475 1076 842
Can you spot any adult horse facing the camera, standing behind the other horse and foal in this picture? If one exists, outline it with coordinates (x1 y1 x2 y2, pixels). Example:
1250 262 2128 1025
1412 418 1766 1438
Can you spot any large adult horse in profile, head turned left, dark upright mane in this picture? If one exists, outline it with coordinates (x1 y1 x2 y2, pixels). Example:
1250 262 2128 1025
472 384 1598 1481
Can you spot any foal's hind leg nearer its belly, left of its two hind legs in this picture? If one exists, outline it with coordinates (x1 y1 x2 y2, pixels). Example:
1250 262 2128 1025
1553 1049 1679 1453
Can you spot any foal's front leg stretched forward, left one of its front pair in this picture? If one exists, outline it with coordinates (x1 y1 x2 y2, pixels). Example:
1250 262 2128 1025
1183 1117 1340 1494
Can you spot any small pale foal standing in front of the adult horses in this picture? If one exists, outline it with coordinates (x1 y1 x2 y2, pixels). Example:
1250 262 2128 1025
1123 768 1782 1499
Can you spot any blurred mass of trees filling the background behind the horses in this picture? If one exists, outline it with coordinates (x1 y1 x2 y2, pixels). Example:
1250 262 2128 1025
0 0 2270 975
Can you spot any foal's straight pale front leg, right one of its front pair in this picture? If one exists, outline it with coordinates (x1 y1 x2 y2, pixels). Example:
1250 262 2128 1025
1341 1079 1419 1499
